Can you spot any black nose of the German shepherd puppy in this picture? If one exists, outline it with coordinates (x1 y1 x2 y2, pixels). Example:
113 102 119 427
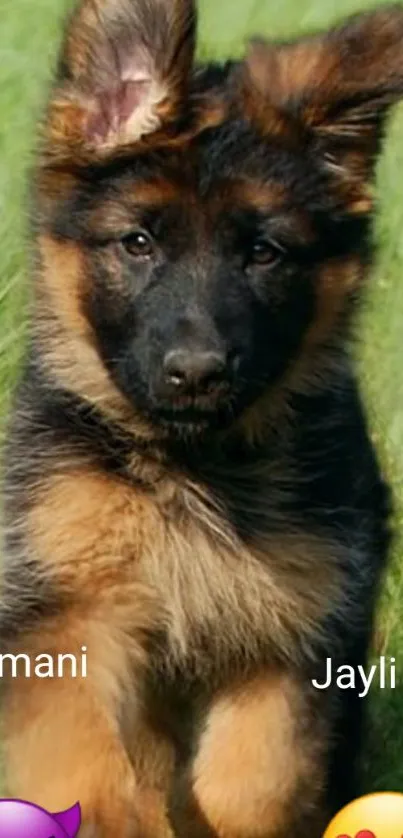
163 349 226 393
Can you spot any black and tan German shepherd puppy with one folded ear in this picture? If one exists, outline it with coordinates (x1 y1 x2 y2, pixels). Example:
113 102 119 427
1 0 403 838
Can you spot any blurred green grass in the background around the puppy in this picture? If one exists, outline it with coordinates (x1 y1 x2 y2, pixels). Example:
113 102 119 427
0 0 403 790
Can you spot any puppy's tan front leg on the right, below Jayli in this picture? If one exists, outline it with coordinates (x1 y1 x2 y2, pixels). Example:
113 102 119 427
178 675 332 838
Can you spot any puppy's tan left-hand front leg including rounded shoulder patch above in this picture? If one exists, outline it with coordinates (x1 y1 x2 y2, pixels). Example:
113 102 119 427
2 473 175 838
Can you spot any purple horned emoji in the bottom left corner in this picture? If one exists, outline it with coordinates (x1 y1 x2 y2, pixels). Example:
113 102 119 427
0 800 81 838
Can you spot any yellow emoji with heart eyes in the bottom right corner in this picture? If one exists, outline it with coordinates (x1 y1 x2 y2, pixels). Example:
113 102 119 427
323 792 403 838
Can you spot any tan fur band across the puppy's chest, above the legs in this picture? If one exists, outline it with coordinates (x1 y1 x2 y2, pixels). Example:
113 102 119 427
29 462 342 680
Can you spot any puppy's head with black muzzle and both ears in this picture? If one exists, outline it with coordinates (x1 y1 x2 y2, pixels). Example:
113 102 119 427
36 0 403 442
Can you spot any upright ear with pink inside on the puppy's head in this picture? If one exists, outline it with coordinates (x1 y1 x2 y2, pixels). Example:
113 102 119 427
45 0 196 161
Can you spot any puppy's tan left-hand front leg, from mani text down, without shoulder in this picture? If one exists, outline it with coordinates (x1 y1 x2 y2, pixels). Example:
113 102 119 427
3 614 171 838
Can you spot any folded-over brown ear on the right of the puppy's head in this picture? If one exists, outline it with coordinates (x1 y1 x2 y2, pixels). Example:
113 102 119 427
243 5 403 212
